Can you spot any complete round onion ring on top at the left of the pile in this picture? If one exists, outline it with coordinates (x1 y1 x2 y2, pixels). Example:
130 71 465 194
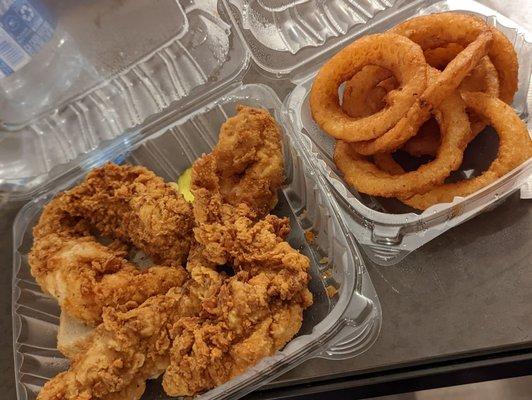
310 33 427 142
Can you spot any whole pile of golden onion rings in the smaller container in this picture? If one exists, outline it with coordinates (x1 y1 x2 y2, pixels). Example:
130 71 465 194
310 13 532 209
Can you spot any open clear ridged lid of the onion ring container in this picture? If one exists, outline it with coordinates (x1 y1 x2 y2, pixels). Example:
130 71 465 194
223 0 412 81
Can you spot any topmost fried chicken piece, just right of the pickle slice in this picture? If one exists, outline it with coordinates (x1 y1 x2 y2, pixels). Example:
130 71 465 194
213 106 284 216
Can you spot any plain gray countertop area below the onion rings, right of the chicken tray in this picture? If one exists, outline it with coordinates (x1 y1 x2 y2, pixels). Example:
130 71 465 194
274 193 532 386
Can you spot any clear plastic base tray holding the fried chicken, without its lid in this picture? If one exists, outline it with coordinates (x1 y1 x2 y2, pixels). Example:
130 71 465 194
13 85 381 400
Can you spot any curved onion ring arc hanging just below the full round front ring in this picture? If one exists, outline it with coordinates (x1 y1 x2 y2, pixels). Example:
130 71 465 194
334 93 470 197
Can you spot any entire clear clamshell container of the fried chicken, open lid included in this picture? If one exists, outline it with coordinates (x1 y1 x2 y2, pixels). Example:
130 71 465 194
10 0 381 400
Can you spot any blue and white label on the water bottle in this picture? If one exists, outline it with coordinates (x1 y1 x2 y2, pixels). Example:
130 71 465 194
0 0 55 78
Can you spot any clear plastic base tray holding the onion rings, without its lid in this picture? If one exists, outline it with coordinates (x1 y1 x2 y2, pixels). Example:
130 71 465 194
285 0 532 265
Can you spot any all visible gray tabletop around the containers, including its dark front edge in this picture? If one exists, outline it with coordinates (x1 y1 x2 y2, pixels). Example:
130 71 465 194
0 0 532 399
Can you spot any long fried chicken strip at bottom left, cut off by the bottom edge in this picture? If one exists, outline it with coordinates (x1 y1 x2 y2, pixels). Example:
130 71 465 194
38 244 224 400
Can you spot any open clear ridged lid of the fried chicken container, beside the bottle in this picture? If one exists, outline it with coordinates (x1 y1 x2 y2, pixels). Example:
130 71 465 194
0 0 249 195
